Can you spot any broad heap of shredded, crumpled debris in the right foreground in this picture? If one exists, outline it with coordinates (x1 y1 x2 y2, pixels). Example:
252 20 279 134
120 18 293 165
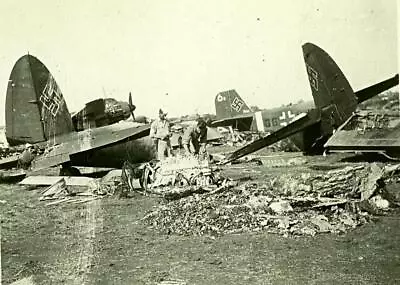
144 164 400 236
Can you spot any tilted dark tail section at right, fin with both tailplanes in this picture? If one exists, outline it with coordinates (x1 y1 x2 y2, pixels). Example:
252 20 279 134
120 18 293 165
223 43 400 163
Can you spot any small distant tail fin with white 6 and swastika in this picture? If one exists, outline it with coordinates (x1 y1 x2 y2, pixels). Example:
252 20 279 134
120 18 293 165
215 90 251 119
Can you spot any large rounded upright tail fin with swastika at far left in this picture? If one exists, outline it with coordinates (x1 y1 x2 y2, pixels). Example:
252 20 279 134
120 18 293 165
6 54 74 146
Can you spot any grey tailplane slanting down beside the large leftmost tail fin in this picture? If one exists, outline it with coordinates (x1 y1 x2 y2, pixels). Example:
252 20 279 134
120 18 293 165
32 122 150 170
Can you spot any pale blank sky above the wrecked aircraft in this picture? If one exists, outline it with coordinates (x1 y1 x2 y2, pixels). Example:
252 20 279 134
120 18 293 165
0 0 398 124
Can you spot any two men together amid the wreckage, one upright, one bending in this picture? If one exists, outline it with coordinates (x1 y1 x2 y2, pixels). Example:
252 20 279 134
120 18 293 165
150 109 207 160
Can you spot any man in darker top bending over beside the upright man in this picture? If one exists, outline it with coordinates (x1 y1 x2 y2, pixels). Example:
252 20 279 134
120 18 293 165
182 118 207 158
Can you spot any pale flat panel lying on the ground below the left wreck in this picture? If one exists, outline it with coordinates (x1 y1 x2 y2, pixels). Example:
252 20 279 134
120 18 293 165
19 176 96 186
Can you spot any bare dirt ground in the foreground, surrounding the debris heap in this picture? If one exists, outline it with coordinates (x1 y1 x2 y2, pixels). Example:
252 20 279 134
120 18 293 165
0 150 400 284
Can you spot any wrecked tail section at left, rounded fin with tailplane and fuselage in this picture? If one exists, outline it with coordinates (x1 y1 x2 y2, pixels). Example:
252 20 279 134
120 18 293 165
6 54 155 172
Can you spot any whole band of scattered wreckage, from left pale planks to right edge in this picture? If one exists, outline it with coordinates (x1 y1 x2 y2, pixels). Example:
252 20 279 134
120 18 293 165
3 142 400 236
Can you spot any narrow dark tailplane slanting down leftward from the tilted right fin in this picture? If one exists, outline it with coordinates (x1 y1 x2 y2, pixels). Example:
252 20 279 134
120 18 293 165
222 109 321 164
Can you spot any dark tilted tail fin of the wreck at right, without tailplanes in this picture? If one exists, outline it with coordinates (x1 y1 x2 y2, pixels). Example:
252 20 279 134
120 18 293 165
303 43 358 125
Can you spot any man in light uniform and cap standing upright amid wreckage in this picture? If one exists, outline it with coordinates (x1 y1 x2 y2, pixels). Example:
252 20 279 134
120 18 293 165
150 109 171 160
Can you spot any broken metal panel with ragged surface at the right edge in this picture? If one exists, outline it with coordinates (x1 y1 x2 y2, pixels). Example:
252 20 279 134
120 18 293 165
325 111 400 152
